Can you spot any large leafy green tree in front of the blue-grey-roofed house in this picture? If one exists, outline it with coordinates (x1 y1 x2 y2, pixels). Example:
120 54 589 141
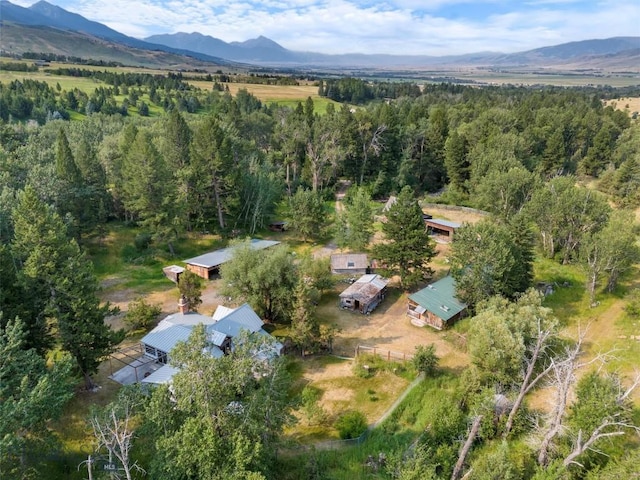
146 326 291 480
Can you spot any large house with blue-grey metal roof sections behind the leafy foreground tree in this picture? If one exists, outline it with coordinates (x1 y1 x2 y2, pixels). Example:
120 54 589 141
140 303 283 384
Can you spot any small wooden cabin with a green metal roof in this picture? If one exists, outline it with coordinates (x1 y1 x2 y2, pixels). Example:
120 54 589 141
407 275 467 330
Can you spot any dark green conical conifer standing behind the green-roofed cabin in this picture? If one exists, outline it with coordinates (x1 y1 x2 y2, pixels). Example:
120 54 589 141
373 186 435 289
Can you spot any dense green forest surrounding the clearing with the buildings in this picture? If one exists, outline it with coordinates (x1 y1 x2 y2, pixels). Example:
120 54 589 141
0 70 640 480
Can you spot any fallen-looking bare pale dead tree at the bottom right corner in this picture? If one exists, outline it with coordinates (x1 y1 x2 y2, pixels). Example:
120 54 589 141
562 374 640 467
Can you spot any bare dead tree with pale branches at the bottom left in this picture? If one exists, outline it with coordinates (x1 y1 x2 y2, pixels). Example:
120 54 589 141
90 397 146 480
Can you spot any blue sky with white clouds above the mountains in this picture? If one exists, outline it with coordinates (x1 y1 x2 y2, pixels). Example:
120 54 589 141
10 0 640 56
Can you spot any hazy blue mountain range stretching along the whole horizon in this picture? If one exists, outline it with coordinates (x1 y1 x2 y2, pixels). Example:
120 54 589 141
0 0 640 72
